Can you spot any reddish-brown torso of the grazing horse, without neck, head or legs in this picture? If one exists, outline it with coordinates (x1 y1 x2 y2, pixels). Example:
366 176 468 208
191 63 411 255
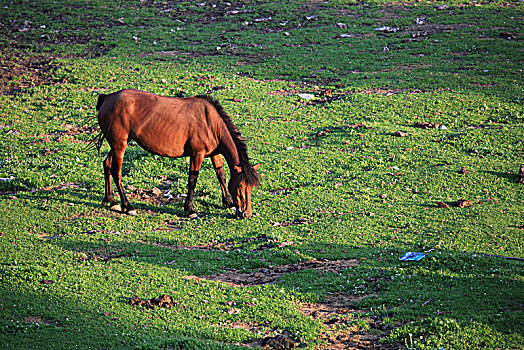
98 89 221 157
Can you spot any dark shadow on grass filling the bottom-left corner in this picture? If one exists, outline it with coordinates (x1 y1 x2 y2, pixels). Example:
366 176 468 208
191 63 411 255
0 279 248 350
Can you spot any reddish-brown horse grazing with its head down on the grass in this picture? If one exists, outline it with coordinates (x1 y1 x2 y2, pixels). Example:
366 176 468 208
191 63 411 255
96 89 260 218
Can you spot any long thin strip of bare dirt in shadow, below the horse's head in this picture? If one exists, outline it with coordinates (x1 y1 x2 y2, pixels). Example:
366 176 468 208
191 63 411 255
188 259 358 287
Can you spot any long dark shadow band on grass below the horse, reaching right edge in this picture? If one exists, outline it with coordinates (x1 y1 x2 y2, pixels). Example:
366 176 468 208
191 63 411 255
45 231 524 335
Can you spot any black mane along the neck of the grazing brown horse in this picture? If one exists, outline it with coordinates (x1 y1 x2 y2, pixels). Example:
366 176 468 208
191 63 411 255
196 95 260 186
